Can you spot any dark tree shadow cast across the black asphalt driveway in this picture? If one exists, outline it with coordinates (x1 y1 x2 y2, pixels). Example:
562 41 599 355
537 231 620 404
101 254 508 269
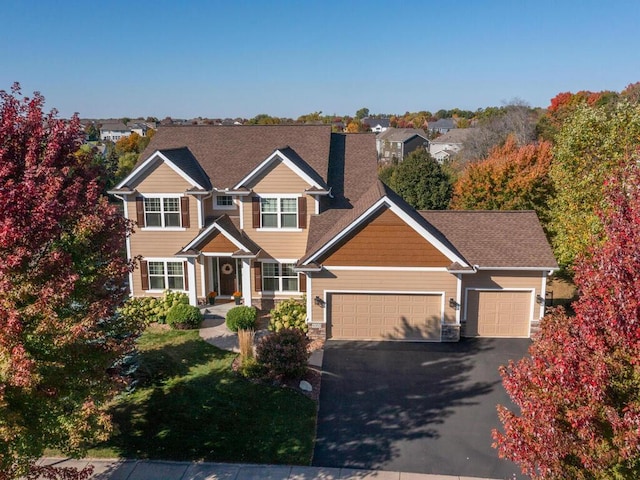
313 339 500 469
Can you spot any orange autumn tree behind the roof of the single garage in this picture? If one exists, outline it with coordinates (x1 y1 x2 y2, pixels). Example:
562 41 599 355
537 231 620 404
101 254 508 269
451 136 553 219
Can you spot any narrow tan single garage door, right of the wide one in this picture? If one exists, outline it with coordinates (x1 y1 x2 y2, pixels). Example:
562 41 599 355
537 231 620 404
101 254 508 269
466 290 532 337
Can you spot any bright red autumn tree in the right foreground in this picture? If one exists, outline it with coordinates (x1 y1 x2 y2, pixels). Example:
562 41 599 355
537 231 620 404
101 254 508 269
493 163 640 479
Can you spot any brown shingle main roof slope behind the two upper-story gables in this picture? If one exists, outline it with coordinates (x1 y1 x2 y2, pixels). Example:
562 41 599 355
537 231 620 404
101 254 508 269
140 125 331 188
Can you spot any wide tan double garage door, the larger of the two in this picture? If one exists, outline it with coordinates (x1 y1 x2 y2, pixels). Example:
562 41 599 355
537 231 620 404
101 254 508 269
328 293 442 341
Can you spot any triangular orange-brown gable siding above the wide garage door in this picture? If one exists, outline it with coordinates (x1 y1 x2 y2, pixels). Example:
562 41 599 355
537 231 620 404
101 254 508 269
320 209 451 267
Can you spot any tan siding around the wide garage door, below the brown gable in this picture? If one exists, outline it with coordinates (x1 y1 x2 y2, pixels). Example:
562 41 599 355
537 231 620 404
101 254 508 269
308 270 457 323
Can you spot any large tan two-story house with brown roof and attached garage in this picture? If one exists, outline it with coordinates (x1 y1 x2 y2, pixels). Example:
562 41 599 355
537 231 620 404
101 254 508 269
110 125 557 341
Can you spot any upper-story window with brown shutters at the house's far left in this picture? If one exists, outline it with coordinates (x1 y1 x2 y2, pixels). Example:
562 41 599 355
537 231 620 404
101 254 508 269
136 196 189 229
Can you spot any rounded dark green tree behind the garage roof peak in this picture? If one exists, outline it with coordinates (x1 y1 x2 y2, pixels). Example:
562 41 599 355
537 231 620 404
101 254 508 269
389 148 452 210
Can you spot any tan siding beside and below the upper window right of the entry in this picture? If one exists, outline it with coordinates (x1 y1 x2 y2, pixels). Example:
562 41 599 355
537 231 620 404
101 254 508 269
243 197 315 259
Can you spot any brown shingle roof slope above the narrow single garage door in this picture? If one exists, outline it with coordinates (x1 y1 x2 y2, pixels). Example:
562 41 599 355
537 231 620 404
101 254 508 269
419 210 558 269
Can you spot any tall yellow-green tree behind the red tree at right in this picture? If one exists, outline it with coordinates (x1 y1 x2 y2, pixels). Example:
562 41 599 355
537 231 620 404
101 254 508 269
549 101 640 267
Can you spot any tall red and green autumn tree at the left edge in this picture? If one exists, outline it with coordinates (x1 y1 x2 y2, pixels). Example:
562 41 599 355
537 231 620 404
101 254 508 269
0 84 140 478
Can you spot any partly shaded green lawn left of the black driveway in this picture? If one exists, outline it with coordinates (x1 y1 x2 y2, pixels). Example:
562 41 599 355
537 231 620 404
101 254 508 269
89 327 316 465
